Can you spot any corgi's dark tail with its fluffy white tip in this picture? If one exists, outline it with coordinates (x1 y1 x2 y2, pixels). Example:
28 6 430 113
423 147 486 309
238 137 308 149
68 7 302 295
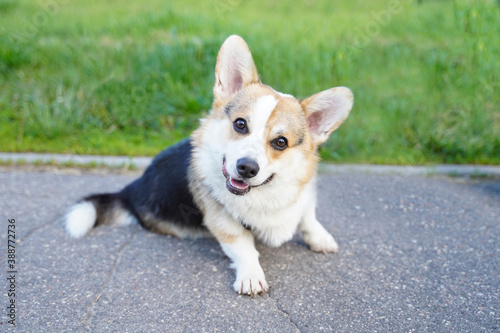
63 193 137 238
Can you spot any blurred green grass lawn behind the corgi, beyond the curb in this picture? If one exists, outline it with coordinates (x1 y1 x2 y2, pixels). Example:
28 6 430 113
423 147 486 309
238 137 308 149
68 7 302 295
0 0 500 164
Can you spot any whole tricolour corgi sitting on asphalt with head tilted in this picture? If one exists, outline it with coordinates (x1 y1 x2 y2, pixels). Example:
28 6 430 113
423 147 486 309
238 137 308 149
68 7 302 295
64 35 353 296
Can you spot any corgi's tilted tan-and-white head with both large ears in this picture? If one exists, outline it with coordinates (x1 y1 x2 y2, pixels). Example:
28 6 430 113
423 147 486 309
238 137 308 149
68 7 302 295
195 36 353 195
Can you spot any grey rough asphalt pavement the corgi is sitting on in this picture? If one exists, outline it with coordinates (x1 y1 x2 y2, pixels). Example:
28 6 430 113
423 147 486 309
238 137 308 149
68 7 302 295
0 167 500 332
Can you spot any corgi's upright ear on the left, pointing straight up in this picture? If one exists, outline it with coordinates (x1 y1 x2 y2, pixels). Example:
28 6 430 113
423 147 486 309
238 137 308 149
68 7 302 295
214 35 260 100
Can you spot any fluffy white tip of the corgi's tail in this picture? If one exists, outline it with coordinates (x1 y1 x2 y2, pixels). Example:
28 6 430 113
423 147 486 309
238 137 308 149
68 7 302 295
64 201 97 238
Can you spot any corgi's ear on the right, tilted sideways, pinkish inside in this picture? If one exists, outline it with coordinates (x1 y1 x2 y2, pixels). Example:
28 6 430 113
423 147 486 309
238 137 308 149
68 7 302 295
301 87 354 145
